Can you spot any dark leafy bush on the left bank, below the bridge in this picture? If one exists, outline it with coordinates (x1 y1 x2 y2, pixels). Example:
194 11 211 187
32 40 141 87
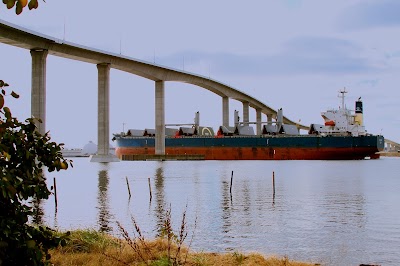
0 80 72 265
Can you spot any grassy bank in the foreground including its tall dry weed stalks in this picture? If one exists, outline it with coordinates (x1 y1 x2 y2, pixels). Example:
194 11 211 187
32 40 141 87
50 206 319 266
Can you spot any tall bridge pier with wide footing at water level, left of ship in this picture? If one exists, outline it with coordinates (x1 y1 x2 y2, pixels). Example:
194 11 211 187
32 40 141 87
90 64 119 163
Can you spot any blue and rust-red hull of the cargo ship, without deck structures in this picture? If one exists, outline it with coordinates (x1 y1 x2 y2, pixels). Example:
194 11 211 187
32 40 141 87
115 136 384 160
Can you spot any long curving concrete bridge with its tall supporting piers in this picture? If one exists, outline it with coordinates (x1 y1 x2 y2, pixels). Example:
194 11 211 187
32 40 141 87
0 20 308 162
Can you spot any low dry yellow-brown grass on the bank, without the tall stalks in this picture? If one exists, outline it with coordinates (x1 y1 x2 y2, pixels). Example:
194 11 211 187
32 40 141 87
50 230 316 266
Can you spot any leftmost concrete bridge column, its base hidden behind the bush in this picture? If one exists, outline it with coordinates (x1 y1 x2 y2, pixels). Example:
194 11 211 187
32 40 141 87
31 50 48 135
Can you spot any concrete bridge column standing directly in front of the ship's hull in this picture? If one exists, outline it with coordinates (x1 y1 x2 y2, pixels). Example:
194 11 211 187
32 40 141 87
155 81 165 155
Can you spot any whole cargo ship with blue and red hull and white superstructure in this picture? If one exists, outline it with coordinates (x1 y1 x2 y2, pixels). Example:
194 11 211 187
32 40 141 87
113 90 384 160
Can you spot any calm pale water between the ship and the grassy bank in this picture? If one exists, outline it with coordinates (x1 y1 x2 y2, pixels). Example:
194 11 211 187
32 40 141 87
42 158 400 265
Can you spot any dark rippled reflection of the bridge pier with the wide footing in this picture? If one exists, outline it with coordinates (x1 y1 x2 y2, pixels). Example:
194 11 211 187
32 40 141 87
97 170 112 232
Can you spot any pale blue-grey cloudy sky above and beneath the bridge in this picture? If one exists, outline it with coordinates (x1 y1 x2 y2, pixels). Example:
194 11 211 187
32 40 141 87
0 0 400 148
